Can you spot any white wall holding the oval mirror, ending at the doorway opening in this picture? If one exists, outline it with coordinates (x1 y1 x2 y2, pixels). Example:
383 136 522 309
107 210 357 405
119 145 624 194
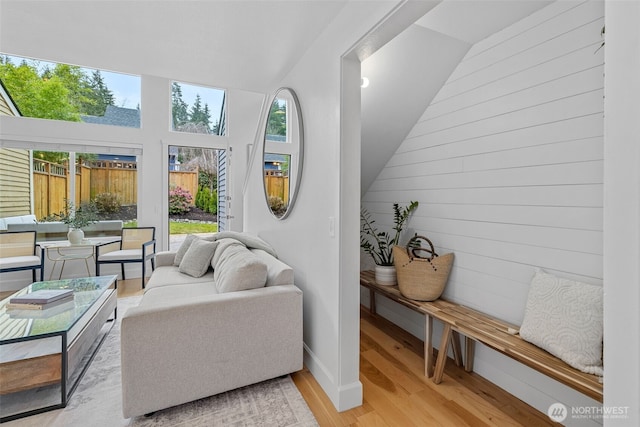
244 1 418 411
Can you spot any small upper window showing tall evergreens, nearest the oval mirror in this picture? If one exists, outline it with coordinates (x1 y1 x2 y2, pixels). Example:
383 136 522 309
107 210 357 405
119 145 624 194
171 82 225 135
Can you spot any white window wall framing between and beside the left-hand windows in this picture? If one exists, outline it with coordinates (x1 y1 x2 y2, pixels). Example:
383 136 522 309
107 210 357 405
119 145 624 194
0 80 264 291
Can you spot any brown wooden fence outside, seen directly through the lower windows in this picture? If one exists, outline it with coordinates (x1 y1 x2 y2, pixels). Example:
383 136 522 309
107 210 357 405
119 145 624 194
33 159 198 220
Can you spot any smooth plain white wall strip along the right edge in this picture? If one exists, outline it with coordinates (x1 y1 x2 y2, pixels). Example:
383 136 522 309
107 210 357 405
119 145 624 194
604 1 640 427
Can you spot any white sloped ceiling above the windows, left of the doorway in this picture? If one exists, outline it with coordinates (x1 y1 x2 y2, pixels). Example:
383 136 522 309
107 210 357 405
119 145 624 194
0 0 346 92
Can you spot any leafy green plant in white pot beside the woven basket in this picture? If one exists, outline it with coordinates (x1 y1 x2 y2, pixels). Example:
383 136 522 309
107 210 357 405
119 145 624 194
360 201 418 285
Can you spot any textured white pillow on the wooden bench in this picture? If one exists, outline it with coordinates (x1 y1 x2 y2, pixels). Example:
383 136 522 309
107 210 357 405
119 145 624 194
520 270 603 375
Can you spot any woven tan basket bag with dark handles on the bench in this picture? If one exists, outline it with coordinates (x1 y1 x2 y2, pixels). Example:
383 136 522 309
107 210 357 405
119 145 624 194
393 235 453 301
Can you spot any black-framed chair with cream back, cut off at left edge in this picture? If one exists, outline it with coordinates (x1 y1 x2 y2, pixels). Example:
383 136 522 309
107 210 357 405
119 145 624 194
0 231 45 282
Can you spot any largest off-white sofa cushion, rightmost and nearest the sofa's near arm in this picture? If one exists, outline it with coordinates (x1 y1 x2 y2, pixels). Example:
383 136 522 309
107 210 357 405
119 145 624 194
213 244 267 293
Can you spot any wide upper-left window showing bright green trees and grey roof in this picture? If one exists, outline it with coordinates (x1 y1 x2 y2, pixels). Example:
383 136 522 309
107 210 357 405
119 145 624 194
0 53 140 128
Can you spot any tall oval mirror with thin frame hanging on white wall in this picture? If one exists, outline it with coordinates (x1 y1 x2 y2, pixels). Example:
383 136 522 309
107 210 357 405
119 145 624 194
262 88 304 219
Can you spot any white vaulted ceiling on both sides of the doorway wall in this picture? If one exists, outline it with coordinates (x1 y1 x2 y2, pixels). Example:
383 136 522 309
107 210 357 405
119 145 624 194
0 0 550 192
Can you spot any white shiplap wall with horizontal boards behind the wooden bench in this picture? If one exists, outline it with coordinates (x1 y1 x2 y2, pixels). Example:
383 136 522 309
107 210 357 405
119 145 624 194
362 1 604 422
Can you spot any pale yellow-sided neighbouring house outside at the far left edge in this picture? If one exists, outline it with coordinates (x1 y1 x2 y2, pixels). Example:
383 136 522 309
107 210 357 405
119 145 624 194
0 81 32 218
